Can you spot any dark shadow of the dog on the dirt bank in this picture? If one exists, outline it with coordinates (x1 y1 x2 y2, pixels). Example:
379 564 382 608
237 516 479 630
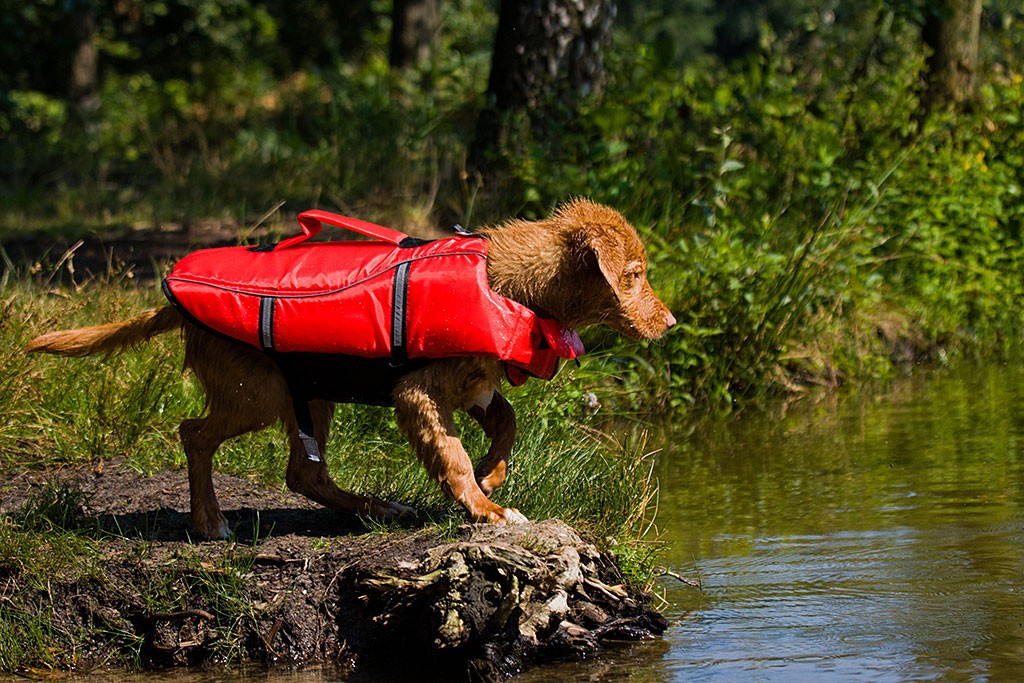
93 507 376 543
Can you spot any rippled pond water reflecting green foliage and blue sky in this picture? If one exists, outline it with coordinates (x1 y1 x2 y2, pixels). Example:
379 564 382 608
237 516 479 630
9 368 1024 683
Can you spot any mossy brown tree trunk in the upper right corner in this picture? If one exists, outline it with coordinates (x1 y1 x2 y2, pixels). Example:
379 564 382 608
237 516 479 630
922 0 981 111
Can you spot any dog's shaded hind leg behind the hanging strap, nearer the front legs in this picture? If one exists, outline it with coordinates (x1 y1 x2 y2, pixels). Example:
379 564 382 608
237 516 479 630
282 400 415 520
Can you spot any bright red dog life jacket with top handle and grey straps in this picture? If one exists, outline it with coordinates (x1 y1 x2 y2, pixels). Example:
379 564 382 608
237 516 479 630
164 211 584 384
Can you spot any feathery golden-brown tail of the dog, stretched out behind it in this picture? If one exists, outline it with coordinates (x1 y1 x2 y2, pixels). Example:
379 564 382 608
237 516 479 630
25 306 184 355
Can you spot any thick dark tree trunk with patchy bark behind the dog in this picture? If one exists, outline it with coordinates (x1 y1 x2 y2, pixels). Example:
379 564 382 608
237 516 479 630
470 0 615 162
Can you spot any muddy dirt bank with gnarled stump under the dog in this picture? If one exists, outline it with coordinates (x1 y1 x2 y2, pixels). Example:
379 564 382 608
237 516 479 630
0 464 666 680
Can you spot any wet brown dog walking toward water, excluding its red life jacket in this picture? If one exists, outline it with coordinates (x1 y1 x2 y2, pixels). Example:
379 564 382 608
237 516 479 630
26 200 676 539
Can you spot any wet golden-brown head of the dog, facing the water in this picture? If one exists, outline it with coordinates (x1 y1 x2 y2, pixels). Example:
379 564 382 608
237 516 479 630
550 200 676 339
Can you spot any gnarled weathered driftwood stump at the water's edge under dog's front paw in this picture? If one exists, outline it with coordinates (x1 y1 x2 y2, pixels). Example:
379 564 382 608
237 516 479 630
341 520 667 680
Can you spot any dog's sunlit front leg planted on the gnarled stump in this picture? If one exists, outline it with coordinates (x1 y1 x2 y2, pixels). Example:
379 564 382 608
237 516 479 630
394 383 526 523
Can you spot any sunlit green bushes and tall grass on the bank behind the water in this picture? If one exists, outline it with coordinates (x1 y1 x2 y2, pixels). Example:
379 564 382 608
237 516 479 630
489 5 1024 411
